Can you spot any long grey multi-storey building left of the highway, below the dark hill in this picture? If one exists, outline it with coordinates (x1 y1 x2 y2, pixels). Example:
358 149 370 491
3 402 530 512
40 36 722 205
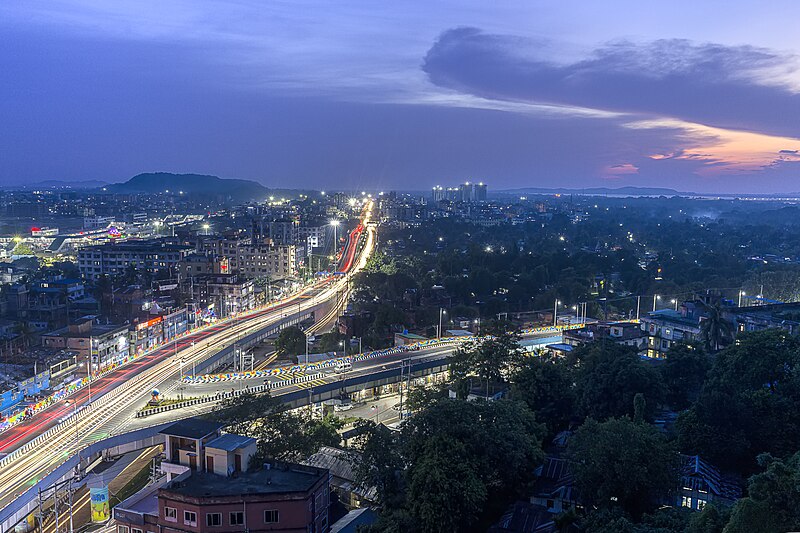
78 240 192 279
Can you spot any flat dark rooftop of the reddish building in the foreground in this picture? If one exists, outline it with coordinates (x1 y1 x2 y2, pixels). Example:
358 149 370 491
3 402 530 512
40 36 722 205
162 465 328 498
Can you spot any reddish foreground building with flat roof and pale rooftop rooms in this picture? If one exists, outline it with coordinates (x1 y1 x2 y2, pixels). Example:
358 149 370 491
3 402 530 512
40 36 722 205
114 419 330 533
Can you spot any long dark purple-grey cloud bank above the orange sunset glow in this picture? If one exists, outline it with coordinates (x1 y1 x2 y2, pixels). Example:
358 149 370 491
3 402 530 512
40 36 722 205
423 28 800 136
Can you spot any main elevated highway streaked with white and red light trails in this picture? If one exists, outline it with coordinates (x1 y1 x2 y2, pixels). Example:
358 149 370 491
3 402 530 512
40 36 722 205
0 204 376 508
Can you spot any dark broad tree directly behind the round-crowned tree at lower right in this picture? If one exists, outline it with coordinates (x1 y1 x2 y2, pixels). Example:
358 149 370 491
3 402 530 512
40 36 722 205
572 343 664 420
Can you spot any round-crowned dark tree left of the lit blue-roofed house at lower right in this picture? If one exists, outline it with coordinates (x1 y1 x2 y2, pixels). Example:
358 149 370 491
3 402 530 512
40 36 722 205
567 417 678 516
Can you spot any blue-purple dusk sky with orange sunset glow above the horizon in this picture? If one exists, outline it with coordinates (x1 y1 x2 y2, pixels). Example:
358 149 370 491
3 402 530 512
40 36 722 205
0 0 800 193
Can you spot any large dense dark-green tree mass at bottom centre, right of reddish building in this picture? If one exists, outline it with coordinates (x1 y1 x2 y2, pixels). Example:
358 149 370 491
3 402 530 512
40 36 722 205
359 399 544 532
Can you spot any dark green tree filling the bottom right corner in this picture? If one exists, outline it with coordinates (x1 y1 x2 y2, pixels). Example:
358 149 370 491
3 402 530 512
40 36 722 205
725 452 800 533
